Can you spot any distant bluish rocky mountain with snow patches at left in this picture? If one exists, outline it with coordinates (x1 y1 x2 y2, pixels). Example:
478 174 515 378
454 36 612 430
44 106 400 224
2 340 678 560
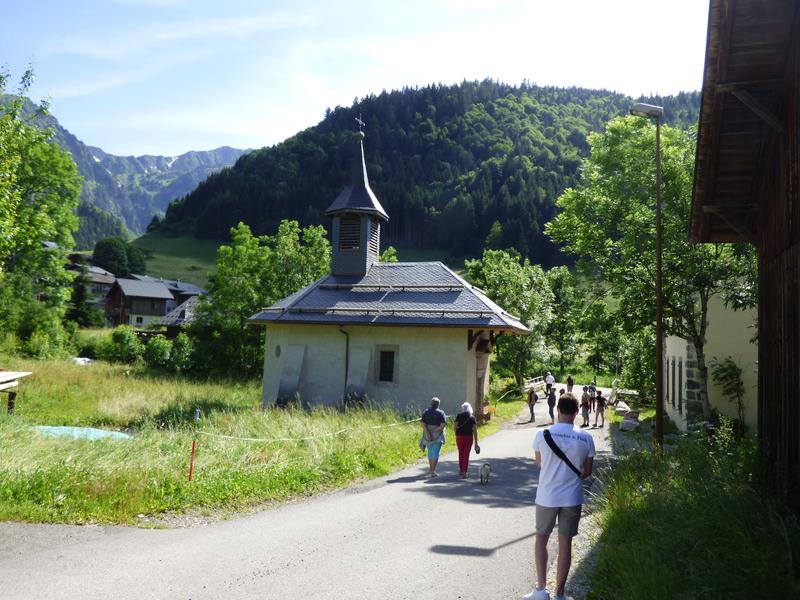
0 97 245 249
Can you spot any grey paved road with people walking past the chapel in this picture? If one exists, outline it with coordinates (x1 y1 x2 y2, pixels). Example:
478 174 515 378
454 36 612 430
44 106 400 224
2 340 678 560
0 402 607 600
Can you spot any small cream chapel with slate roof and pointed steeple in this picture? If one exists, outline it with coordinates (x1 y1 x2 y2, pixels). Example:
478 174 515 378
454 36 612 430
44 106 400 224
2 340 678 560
250 132 528 413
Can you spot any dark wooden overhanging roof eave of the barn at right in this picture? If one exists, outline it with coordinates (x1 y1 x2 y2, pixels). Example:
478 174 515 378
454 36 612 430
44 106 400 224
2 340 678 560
690 0 800 243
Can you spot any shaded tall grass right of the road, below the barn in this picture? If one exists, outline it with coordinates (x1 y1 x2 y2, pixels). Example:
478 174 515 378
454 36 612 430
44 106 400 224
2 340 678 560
589 426 800 600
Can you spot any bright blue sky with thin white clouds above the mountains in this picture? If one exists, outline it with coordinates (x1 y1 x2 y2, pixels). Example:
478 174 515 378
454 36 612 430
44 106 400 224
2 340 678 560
0 0 708 155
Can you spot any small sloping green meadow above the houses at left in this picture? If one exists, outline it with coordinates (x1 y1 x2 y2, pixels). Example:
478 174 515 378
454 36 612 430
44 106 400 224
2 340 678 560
132 233 221 287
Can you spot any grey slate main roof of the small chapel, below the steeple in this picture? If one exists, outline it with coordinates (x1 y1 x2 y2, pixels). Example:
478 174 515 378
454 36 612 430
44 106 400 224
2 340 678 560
249 262 529 335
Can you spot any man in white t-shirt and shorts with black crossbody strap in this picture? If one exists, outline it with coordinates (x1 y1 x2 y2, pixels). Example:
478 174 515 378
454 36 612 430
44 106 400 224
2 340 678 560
523 393 595 600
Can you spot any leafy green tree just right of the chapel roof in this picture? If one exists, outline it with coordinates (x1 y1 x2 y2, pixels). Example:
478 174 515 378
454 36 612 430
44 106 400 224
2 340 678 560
465 250 553 386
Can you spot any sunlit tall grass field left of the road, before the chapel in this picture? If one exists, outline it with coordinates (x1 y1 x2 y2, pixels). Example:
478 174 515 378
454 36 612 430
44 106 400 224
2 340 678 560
0 355 523 524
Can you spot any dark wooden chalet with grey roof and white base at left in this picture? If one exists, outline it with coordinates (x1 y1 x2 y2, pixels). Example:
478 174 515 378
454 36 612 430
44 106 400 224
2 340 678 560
106 278 174 327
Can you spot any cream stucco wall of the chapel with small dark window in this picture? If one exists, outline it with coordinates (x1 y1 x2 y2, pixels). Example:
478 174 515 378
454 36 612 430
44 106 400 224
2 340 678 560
263 323 489 414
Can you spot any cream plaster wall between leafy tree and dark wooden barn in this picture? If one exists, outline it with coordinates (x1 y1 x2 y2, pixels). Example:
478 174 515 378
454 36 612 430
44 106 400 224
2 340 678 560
705 296 758 430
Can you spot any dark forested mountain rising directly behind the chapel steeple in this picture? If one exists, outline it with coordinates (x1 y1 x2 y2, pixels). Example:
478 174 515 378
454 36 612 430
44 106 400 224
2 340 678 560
159 80 699 265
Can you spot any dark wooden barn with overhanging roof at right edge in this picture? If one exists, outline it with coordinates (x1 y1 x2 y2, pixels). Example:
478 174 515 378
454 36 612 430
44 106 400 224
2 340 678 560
690 0 800 512
